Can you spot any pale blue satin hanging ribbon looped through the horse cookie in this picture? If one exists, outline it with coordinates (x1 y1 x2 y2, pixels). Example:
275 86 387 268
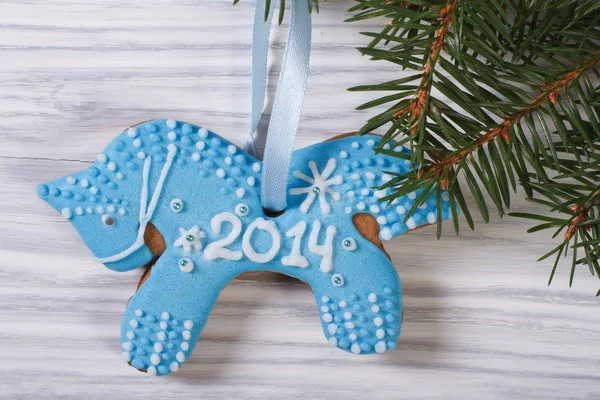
244 0 312 212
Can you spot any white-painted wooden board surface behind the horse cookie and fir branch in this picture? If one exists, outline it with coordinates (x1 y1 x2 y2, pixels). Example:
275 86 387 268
0 0 600 399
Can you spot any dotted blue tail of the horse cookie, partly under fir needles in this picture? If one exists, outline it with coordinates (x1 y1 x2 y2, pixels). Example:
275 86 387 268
322 134 452 241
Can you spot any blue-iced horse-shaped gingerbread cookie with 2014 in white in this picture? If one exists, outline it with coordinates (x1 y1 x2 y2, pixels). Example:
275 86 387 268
37 120 451 375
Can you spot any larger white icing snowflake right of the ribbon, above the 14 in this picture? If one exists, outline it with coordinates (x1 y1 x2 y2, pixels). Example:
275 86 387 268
290 158 343 214
